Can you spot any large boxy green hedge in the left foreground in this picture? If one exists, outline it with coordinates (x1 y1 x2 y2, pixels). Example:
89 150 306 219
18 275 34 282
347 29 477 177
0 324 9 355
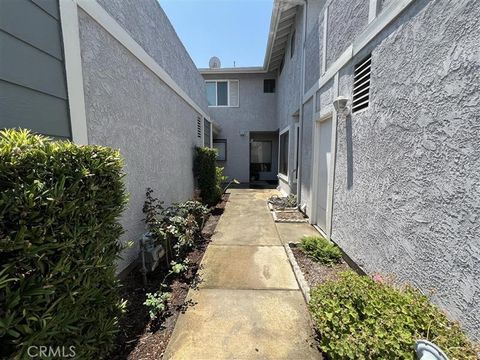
0 130 126 358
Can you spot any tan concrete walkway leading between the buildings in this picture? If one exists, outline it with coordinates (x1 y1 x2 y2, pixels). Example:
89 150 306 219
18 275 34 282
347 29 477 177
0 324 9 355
164 190 321 360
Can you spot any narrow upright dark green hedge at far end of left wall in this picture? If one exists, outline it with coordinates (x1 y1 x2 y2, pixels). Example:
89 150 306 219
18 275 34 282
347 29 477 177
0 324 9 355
194 147 222 206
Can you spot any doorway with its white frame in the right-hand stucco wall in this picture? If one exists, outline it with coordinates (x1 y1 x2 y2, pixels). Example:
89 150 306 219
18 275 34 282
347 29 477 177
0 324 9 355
312 116 333 234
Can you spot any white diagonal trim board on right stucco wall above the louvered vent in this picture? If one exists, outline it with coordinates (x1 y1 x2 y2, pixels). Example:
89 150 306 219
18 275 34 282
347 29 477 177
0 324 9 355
302 0 415 103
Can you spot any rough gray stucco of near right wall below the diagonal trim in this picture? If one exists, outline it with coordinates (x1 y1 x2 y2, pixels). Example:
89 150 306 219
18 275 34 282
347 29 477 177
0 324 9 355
332 0 480 339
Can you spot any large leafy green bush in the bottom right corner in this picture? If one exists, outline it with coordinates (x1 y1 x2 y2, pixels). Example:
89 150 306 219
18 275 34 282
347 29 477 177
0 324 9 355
309 271 476 360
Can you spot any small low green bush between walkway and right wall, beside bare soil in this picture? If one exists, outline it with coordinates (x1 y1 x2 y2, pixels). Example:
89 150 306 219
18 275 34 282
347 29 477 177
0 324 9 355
299 236 342 266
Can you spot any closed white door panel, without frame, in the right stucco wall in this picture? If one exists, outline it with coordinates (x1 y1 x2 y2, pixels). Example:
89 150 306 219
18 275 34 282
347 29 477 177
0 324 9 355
316 118 332 232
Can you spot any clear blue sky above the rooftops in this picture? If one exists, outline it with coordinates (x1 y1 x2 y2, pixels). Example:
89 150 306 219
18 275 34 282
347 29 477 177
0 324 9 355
159 0 273 67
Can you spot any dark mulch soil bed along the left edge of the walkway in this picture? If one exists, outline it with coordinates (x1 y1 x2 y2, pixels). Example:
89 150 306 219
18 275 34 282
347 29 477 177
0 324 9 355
108 194 228 360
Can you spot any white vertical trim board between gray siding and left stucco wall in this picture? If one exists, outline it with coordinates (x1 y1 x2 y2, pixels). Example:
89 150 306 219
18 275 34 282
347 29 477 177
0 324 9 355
59 0 88 145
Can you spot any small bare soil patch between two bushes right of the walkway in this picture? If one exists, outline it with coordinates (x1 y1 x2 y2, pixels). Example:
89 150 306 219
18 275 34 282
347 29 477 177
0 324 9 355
290 244 350 288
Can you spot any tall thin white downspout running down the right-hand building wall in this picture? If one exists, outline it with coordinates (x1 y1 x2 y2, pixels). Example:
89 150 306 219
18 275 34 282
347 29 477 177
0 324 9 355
295 0 308 207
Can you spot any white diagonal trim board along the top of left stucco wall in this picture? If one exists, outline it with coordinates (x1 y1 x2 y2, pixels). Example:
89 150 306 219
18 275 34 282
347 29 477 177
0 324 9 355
72 0 210 124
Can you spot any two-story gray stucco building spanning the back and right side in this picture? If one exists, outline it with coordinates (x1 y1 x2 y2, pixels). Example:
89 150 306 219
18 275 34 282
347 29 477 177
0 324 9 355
200 0 480 338
